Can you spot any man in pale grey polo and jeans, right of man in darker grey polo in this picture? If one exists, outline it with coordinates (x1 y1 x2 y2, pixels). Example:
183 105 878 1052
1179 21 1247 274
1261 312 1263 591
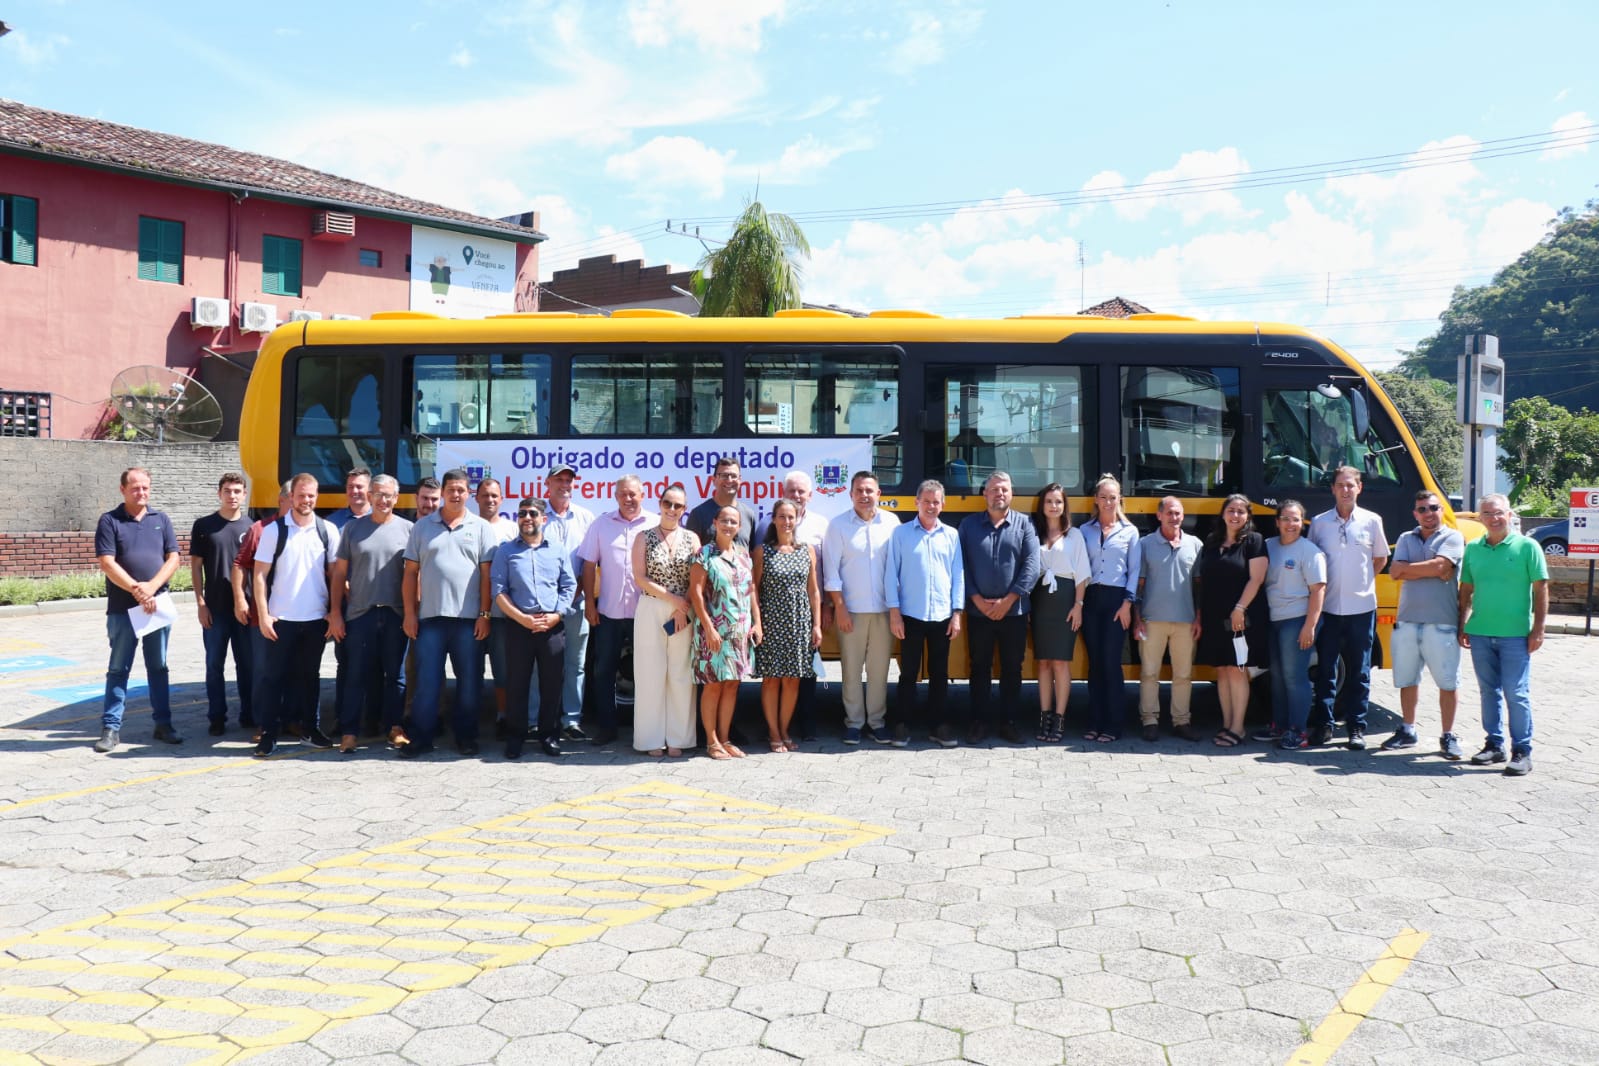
400 470 500 759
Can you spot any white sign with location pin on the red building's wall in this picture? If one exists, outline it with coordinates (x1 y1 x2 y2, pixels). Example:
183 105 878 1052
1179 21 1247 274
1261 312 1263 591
411 225 516 318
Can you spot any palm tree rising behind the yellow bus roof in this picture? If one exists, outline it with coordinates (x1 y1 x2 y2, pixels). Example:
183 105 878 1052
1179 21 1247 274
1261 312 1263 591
694 200 811 318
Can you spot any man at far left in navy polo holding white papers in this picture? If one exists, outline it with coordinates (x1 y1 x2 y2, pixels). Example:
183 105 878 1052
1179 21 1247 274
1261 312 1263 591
94 467 184 754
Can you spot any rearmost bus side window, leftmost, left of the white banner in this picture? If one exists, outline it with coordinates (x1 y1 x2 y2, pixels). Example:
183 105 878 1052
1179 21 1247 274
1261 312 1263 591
288 353 389 492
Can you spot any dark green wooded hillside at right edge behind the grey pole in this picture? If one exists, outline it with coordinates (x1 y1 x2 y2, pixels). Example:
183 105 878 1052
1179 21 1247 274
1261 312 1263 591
1401 200 1599 409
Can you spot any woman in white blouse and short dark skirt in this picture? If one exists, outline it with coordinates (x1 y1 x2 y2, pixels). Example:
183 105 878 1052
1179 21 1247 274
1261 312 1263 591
1031 481 1089 743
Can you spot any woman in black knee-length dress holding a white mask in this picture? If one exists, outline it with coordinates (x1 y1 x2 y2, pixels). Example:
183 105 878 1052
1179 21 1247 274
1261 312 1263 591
1196 492 1271 748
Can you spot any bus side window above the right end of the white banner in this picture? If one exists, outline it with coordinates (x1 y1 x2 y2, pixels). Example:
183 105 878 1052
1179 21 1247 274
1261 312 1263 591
742 350 905 486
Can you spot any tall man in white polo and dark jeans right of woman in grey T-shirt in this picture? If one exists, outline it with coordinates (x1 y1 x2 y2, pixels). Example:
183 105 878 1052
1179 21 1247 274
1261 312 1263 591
1308 467 1388 751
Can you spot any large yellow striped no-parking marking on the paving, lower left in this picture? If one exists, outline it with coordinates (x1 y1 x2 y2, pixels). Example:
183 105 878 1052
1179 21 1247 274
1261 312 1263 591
0 779 891 1064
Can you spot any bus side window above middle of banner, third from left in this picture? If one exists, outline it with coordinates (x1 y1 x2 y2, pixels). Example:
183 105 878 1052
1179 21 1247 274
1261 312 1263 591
571 352 724 436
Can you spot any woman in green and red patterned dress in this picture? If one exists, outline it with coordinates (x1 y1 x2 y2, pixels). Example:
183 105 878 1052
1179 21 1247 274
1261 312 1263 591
689 507 761 759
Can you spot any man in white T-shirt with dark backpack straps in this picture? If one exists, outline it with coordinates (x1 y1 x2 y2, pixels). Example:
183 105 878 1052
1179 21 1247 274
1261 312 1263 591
251 473 339 759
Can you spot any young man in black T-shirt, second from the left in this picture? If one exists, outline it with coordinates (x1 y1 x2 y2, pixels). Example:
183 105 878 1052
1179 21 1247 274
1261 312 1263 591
189 470 256 737
